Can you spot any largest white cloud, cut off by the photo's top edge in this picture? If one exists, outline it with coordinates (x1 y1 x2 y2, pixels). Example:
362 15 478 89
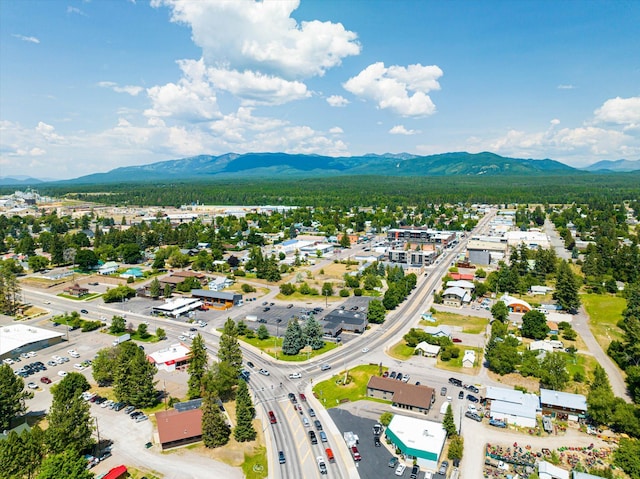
151 0 360 79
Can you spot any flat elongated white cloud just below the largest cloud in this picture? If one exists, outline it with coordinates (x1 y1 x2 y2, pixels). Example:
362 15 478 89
208 68 311 105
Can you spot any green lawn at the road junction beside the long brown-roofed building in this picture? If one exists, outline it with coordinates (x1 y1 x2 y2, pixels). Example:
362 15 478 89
313 364 390 408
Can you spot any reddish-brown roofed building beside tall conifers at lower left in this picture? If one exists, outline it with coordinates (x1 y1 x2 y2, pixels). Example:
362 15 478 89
156 408 202 450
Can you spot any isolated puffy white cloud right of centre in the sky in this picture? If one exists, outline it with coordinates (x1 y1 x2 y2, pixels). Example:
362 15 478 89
343 62 442 117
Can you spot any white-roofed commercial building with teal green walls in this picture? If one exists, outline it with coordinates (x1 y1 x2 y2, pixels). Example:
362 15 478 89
385 414 447 470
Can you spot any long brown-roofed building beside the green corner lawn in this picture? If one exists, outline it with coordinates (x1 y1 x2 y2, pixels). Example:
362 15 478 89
367 376 436 414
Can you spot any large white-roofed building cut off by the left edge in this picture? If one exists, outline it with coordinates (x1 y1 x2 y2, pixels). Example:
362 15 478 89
0 324 65 360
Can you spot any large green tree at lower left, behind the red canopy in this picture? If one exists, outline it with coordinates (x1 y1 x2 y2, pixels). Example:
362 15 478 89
43 373 93 454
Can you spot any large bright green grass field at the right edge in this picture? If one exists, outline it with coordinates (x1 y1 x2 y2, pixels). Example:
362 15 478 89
580 294 627 351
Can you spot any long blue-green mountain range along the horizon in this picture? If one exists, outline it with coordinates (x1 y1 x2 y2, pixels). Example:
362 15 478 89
0 152 640 186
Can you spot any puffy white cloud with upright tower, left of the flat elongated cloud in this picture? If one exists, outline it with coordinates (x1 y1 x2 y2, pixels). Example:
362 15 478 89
144 60 220 122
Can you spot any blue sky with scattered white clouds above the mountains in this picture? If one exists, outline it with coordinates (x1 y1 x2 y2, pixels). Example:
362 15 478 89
0 0 640 178
